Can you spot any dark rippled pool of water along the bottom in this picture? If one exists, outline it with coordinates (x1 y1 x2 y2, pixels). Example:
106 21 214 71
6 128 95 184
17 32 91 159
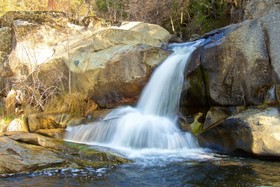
0 155 280 187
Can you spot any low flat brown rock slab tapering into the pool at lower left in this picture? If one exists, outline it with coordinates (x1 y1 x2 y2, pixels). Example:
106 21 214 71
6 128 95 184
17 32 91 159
0 132 127 175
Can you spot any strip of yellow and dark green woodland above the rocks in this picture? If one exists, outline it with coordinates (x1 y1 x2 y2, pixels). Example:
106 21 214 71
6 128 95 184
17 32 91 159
0 0 241 40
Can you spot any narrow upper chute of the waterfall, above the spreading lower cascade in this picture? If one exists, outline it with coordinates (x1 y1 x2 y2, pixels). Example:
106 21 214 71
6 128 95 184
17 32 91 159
137 40 201 119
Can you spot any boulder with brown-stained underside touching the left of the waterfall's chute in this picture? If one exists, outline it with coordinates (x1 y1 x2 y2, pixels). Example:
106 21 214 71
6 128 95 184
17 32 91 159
66 45 169 107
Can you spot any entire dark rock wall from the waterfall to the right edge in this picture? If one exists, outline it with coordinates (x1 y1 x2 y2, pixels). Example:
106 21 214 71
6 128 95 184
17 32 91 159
181 13 280 107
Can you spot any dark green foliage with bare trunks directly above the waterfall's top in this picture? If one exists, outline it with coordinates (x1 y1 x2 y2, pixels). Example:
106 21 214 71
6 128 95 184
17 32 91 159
162 0 233 39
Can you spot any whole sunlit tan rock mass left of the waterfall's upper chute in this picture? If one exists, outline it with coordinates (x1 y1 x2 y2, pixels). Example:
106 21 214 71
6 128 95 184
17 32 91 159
0 12 171 110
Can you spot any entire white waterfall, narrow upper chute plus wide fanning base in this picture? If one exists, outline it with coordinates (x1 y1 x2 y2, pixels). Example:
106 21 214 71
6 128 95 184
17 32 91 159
65 40 206 150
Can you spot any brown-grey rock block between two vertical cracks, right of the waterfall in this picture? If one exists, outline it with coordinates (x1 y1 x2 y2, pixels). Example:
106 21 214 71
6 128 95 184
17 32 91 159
201 21 273 106
